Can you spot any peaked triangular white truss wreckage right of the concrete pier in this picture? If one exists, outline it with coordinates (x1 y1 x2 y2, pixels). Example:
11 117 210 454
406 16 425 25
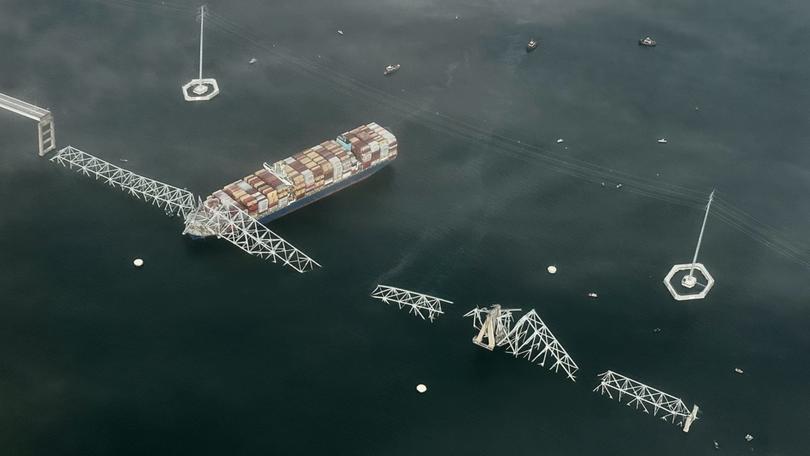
504 309 579 381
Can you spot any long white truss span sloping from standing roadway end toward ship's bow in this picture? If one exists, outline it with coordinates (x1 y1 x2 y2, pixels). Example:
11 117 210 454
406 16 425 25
51 146 196 217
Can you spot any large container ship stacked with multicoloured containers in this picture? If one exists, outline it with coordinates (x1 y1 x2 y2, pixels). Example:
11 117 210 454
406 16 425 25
197 122 397 232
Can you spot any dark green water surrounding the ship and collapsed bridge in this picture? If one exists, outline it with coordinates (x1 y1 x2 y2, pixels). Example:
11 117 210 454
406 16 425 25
0 0 810 455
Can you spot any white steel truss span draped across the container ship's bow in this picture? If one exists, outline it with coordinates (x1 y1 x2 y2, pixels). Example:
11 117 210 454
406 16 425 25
183 198 321 273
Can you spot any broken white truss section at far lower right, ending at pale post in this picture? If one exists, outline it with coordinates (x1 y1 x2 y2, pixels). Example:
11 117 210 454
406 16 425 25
593 370 699 432
